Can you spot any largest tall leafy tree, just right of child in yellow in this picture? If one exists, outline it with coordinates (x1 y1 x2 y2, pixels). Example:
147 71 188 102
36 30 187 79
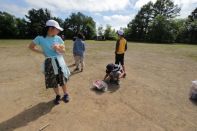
126 0 180 43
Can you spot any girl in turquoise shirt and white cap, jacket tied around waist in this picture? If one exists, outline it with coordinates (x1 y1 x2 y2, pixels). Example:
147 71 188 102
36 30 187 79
29 20 70 104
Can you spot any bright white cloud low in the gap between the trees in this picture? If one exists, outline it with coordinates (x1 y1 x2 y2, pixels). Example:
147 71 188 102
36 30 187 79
103 15 134 30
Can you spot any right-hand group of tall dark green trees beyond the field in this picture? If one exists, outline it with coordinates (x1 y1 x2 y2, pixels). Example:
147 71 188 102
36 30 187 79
125 0 197 44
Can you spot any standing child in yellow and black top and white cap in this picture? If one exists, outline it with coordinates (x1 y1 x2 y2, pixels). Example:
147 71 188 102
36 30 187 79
115 30 127 77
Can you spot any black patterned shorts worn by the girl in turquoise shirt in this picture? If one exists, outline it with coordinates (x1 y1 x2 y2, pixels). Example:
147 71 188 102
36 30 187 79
44 58 67 88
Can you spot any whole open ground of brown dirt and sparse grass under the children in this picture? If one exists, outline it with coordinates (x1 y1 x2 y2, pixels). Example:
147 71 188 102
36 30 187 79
0 40 197 131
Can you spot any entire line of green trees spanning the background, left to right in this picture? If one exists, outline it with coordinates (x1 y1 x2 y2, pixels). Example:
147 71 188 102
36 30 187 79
0 0 197 44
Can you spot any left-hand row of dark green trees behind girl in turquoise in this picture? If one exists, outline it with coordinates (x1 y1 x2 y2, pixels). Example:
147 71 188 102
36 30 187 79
0 8 96 39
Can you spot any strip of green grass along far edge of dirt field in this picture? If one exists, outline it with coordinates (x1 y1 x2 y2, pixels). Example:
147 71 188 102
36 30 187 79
0 40 197 61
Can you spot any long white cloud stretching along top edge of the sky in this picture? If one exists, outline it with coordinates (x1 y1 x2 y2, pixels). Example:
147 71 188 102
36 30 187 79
25 0 130 12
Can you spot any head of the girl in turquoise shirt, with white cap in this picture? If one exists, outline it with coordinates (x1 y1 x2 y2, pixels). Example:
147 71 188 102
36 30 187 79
43 20 63 37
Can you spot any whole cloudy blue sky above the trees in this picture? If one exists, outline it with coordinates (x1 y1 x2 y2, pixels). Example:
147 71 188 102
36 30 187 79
0 0 197 29
